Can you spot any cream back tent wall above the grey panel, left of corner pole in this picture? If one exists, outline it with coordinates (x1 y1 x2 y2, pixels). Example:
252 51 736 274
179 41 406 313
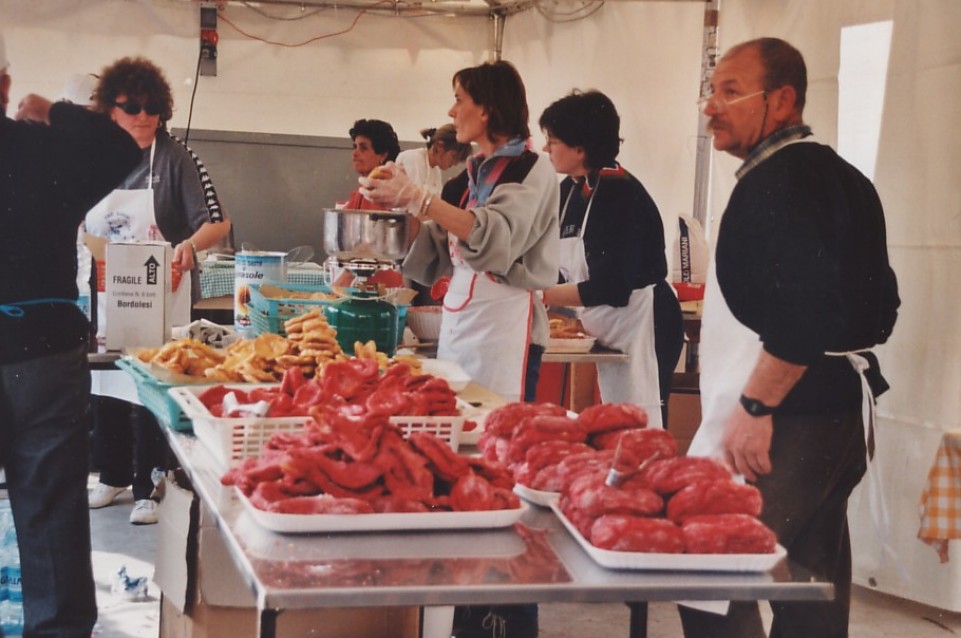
0 0 489 141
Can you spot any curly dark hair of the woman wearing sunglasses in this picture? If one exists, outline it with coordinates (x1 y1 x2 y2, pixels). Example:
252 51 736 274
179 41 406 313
93 57 174 125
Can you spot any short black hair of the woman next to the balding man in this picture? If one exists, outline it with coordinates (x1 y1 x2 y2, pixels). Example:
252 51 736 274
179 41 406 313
538 89 621 170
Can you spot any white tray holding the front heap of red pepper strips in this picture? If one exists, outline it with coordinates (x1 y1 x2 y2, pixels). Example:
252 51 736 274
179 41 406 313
237 490 529 534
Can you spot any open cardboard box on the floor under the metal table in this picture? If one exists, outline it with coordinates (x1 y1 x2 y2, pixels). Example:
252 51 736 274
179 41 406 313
154 475 420 638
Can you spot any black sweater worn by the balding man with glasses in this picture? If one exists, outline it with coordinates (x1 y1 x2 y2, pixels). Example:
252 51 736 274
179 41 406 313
716 143 900 413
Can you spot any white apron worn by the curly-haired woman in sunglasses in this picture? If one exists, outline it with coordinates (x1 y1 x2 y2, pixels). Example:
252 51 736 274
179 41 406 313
84 140 163 341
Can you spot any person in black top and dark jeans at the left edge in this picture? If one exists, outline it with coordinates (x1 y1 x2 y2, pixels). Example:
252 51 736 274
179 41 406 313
0 34 140 637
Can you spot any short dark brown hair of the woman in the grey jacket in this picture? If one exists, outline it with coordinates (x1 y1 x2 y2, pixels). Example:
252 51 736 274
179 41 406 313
452 60 531 141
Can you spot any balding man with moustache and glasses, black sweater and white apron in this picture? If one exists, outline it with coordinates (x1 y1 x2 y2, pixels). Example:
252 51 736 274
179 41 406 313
681 38 900 638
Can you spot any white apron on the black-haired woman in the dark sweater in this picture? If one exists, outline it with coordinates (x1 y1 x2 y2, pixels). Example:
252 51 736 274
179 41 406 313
559 183 664 428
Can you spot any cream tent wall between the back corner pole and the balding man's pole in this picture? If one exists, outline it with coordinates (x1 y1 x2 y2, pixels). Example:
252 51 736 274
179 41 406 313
503 2 704 248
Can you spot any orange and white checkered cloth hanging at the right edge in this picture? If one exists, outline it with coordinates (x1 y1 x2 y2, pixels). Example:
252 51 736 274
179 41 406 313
918 429 961 563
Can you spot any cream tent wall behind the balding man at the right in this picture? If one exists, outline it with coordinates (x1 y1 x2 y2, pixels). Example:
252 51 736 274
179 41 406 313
711 0 961 611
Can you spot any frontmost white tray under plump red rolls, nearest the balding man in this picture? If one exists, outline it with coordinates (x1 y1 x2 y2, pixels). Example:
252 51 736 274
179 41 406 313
550 499 787 572
